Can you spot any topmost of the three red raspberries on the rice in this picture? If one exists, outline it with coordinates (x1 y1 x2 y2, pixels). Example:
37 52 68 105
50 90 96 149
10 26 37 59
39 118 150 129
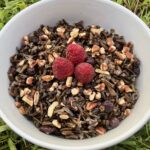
66 44 86 65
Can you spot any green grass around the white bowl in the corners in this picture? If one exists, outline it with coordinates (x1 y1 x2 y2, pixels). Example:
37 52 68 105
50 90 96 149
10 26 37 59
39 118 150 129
0 0 150 150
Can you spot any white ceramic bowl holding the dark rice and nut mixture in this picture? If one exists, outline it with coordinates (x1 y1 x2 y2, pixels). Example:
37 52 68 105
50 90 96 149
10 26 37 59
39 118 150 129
0 0 150 150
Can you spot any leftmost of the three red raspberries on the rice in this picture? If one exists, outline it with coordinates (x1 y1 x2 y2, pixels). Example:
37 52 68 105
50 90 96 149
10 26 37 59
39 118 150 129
52 57 74 80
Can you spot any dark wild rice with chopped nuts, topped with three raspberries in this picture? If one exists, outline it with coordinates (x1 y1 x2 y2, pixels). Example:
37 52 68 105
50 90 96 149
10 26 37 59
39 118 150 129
8 20 140 139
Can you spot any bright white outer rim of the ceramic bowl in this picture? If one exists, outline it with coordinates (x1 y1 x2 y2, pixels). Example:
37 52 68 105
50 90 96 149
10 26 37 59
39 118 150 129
0 0 150 150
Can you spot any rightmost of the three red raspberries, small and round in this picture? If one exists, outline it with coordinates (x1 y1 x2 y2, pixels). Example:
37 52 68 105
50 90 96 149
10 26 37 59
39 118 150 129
75 63 95 83
